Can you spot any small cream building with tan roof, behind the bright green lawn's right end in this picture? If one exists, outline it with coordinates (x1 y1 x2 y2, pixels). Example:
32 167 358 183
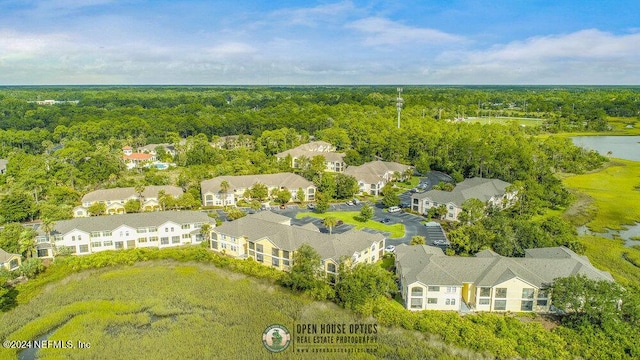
344 160 412 195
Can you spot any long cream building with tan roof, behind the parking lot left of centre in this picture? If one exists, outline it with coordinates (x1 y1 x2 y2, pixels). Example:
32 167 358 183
200 173 316 206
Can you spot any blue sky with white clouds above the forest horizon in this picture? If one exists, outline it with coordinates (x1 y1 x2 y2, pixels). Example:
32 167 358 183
0 0 640 85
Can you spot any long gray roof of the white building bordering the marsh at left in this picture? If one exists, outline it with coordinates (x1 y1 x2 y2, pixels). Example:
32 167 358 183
39 211 214 235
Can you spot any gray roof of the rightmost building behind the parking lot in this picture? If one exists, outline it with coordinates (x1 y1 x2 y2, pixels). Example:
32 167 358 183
411 177 511 206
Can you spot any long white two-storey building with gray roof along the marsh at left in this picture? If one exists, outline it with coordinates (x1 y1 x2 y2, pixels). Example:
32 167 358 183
36 211 215 257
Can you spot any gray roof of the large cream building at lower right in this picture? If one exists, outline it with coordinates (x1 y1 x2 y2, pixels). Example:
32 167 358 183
396 245 613 287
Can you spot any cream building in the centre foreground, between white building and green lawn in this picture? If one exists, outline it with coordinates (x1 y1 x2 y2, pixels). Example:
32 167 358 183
211 211 385 274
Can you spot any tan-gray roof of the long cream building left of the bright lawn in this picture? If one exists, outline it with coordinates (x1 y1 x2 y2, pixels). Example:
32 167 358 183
200 173 313 194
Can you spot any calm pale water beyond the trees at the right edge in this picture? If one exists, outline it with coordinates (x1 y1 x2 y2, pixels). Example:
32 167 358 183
571 136 640 161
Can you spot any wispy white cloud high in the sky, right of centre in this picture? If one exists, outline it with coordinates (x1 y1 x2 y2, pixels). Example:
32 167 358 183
347 17 466 46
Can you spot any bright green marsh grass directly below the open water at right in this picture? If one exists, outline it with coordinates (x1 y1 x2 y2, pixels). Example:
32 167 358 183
563 159 640 232
